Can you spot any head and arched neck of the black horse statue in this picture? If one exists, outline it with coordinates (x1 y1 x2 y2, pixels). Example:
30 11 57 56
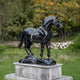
42 16 63 30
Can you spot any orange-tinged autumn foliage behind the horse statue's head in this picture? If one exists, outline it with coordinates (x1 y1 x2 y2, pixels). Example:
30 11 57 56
33 0 80 40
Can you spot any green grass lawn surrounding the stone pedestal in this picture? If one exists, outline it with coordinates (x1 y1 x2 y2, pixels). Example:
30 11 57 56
0 46 80 80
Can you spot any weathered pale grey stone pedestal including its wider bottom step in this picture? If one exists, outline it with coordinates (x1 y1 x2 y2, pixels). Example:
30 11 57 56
5 63 73 80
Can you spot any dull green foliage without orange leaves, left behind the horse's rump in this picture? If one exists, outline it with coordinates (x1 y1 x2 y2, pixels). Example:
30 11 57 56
0 0 34 40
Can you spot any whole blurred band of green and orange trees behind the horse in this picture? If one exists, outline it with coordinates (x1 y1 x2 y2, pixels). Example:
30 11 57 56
0 0 80 41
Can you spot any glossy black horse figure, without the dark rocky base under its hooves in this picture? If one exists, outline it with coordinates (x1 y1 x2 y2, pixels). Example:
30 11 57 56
18 16 62 64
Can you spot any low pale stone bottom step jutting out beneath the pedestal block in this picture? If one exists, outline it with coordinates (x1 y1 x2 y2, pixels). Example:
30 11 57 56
5 73 73 80
